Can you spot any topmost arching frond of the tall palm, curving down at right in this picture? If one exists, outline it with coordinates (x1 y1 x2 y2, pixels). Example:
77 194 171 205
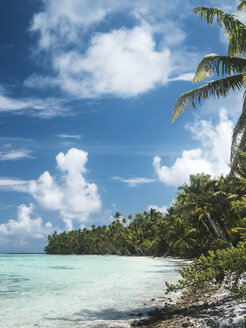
193 7 246 56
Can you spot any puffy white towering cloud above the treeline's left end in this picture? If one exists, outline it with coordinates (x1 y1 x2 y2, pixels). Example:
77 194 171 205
29 148 101 229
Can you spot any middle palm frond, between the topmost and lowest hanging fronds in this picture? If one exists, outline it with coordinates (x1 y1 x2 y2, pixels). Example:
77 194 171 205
193 54 246 82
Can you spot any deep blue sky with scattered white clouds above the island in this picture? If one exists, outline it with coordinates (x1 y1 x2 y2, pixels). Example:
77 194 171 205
0 0 243 252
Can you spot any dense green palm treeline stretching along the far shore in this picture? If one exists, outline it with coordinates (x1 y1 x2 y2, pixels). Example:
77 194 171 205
45 153 246 257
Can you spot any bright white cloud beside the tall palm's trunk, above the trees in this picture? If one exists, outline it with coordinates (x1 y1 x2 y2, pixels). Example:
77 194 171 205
153 108 233 186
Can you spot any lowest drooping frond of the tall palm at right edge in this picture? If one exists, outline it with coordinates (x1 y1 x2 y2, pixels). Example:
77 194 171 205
172 74 244 123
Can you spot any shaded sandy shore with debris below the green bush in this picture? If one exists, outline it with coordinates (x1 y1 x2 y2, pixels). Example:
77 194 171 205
133 285 246 328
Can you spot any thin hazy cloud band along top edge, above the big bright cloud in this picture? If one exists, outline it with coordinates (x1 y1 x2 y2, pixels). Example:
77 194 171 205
31 0 192 50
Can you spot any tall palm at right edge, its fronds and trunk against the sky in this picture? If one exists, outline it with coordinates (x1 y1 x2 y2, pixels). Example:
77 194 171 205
173 0 246 174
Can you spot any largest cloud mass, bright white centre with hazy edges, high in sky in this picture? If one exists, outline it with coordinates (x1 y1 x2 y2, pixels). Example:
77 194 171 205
24 0 204 98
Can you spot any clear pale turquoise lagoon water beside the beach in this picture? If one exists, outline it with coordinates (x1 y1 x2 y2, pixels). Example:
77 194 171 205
0 254 182 328
